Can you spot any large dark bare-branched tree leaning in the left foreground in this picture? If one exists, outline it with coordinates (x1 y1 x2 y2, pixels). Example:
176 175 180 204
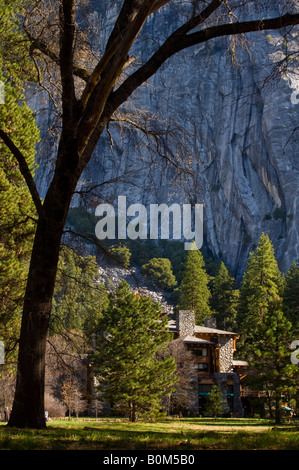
0 0 299 428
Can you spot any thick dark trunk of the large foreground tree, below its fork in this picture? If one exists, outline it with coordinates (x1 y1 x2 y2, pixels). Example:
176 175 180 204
8 150 79 428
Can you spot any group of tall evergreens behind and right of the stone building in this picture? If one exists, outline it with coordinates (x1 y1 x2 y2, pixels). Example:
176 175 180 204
178 233 299 424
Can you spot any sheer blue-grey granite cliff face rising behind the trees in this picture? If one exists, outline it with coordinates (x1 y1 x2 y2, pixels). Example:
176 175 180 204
31 2 299 276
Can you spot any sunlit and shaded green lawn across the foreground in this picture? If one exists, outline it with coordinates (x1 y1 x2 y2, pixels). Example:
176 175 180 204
0 418 299 450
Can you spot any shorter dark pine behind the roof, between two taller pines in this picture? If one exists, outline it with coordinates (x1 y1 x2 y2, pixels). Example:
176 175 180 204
210 262 239 331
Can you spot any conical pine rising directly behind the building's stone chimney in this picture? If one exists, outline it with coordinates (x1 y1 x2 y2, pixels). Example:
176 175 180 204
178 246 211 325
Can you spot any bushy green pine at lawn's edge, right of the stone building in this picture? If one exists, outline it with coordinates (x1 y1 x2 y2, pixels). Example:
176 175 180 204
251 305 298 424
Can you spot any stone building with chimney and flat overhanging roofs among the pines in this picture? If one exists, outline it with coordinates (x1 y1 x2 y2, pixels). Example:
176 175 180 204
169 310 246 416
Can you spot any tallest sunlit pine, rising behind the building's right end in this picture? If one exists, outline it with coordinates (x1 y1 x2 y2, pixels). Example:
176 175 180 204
237 233 283 358
